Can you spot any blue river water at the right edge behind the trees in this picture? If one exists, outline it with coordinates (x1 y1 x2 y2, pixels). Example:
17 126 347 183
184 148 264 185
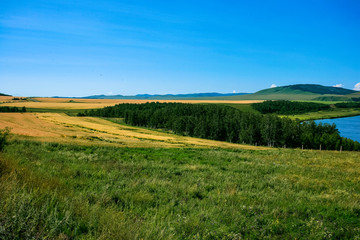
315 116 360 142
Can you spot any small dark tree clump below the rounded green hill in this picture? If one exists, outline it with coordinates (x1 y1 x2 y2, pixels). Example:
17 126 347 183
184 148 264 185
251 100 330 115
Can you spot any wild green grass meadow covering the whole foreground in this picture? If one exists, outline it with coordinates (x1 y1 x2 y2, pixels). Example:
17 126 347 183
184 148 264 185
0 141 360 239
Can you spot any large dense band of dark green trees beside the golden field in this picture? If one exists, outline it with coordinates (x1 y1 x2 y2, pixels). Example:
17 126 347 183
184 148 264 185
79 103 360 150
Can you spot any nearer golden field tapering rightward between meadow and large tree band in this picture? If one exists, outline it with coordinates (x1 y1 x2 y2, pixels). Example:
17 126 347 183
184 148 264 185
0 113 268 150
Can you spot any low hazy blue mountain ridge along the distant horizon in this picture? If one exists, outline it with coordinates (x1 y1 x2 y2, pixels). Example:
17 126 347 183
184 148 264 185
82 93 247 100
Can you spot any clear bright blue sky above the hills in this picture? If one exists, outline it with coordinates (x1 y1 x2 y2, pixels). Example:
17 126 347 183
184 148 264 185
0 0 360 96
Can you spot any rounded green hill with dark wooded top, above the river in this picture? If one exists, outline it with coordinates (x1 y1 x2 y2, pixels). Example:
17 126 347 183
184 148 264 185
195 84 358 101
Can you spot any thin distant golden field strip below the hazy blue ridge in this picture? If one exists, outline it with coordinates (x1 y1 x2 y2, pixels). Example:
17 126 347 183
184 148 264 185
0 97 262 109
